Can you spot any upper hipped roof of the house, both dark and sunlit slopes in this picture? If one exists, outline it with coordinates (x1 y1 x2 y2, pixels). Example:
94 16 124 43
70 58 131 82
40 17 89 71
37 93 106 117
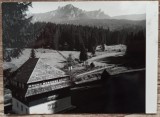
14 58 68 84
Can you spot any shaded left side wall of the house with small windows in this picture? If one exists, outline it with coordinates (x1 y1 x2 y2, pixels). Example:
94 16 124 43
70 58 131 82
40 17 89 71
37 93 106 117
12 97 29 114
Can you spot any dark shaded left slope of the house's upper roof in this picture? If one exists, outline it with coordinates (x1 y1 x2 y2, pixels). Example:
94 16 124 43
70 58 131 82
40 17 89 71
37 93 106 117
13 58 38 83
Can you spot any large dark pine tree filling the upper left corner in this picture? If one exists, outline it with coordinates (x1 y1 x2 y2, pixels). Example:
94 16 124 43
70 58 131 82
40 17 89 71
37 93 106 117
2 2 31 59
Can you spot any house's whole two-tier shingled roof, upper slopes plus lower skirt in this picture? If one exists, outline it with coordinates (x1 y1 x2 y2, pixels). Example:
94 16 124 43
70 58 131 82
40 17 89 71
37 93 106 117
14 54 71 97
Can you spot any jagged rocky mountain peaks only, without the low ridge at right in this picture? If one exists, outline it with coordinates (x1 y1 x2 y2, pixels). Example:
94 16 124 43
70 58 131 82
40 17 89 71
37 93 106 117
31 4 110 23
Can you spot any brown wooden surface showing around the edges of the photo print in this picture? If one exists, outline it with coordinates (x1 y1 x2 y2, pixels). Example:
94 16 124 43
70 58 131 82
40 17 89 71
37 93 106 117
0 0 160 117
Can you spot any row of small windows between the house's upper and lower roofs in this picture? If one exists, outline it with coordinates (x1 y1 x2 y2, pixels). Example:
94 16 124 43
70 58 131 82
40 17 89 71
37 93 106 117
28 78 69 88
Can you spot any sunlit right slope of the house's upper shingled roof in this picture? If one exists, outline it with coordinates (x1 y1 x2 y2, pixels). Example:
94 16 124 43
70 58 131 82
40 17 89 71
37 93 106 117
27 58 68 83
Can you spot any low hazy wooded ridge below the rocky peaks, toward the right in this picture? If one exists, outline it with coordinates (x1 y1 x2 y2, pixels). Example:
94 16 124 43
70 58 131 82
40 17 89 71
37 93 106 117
59 19 146 30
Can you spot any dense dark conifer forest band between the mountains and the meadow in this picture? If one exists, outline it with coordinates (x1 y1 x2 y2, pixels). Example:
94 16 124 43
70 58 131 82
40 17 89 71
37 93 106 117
33 23 145 53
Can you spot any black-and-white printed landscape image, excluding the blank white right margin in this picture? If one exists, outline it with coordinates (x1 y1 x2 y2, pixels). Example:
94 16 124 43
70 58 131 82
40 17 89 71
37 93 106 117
2 1 159 114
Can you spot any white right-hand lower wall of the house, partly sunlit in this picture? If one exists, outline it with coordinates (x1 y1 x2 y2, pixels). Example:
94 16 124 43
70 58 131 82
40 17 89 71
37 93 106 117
29 97 72 114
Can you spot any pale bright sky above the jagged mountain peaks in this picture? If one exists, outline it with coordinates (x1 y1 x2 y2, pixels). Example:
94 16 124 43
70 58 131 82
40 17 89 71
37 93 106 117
28 1 146 16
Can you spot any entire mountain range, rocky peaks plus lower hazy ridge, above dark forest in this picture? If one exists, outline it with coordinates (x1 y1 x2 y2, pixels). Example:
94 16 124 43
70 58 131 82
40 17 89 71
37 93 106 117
27 4 146 30
